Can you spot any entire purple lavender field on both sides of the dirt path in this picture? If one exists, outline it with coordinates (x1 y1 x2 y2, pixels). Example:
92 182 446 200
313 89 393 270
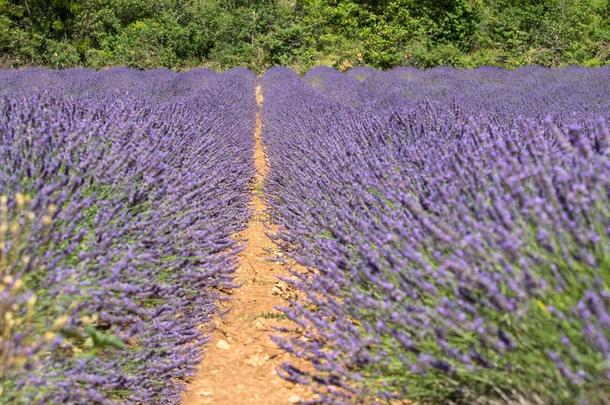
0 67 610 404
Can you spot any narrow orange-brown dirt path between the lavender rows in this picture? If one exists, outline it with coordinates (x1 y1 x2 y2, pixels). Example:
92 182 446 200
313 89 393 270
182 86 307 405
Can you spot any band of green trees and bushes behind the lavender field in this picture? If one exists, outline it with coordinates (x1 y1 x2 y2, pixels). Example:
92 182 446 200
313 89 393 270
0 0 610 71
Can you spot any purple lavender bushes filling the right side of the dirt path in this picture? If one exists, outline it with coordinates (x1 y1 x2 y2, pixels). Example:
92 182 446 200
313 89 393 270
263 68 610 404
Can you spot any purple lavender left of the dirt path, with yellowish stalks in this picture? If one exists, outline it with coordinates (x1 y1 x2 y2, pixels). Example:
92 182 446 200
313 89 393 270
0 68 256 404
